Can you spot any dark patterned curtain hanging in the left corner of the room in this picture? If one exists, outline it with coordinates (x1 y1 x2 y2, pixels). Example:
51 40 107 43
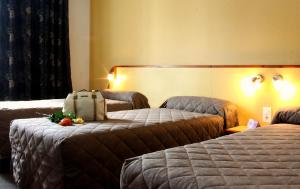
0 0 72 100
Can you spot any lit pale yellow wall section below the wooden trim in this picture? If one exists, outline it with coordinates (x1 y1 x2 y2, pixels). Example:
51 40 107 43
111 68 300 125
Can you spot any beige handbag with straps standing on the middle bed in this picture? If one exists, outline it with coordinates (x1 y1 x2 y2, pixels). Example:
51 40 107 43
63 90 107 121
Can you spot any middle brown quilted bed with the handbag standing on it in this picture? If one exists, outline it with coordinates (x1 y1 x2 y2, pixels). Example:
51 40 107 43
10 97 238 189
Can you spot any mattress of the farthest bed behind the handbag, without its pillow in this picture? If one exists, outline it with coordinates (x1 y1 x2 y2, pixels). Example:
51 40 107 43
0 99 133 159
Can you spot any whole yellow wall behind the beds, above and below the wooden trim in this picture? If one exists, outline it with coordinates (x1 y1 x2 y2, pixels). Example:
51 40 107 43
90 0 300 123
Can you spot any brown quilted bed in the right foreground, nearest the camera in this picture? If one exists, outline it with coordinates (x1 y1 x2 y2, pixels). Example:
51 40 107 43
121 108 300 189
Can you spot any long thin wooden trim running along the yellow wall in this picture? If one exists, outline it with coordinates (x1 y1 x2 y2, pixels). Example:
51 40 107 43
109 64 300 74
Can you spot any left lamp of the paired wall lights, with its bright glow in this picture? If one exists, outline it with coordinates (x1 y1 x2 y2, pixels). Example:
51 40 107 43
241 74 264 97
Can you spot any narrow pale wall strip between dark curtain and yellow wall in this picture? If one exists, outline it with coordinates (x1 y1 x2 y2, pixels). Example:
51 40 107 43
69 0 91 90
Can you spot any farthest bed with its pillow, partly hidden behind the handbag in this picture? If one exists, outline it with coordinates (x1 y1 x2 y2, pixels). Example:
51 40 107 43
0 90 149 161
